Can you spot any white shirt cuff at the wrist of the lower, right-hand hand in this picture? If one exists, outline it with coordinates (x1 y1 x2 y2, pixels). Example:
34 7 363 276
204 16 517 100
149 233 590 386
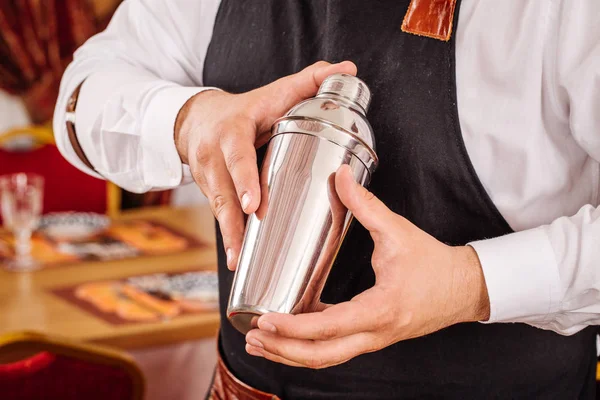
469 228 560 323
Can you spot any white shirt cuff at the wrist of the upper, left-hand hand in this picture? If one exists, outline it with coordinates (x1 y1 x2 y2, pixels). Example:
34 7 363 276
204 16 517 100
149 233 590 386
141 86 218 189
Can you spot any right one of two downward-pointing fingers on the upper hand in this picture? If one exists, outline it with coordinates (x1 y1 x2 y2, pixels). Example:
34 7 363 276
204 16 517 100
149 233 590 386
220 125 260 214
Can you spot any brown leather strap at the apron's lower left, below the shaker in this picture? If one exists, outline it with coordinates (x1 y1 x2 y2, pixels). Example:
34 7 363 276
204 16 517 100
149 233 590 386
208 354 279 400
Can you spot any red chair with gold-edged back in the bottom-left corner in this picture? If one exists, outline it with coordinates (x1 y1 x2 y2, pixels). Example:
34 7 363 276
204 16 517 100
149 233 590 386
0 333 144 400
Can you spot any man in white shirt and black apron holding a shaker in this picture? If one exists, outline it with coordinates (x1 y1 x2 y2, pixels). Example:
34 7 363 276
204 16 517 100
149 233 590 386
55 0 600 399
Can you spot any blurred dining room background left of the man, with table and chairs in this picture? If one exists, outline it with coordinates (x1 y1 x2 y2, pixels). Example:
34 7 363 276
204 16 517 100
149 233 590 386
0 0 218 399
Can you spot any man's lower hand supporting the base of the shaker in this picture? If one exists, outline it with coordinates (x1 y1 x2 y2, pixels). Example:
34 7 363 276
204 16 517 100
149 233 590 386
246 167 490 368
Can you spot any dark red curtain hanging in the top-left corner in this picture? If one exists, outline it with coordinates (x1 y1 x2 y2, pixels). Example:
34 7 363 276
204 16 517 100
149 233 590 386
0 0 99 124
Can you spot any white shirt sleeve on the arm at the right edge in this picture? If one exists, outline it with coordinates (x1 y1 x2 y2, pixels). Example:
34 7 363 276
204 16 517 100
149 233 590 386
470 0 600 335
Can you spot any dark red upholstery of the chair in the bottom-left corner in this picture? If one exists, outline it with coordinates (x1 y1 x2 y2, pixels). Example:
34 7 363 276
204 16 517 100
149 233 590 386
0 352 134 400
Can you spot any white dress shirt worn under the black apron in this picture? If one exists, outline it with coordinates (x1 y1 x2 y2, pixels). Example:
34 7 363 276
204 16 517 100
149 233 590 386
54 0 600 334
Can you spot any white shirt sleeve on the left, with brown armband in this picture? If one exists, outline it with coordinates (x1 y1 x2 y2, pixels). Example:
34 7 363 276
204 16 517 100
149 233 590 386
54 0 219 193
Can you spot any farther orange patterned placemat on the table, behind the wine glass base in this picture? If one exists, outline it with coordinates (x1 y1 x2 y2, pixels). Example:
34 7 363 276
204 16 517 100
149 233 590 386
0 219 206 267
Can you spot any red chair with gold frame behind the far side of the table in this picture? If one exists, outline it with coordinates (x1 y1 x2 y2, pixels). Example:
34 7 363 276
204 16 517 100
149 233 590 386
0 126 121 219
